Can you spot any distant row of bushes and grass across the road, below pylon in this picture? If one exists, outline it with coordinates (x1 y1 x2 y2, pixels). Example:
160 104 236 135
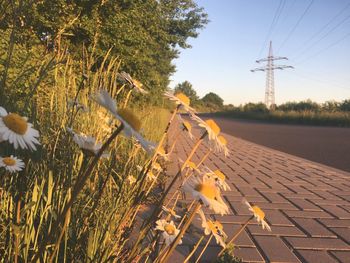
175 81 350 127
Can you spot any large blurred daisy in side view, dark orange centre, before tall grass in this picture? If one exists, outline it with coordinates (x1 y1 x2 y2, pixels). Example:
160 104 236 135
93 90 153 154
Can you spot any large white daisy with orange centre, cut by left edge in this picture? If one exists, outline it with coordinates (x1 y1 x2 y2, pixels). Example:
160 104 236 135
0 107 40 151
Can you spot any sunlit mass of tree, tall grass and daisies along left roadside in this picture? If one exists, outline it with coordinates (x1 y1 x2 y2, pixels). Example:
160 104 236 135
0 0 270 263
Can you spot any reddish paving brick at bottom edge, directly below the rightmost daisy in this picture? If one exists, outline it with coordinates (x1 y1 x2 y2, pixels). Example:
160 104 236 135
254 236 300 262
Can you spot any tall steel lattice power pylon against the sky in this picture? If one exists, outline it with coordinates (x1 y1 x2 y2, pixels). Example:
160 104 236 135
251 41 294 109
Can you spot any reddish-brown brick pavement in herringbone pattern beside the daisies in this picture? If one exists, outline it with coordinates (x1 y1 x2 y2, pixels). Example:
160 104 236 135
165 121 350 263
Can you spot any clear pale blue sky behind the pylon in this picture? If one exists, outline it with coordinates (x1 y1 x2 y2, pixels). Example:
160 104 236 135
170 0 350 105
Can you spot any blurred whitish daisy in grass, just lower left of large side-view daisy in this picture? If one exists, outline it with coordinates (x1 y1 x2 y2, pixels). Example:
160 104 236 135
67 128 109 158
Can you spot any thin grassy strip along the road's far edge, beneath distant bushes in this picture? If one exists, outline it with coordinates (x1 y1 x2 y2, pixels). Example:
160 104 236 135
217 111 350 127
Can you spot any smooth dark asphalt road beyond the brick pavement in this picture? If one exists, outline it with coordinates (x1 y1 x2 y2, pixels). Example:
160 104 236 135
197 114 350 171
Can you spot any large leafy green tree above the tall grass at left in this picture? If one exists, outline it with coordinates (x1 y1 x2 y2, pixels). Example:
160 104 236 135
0 0 208 105
